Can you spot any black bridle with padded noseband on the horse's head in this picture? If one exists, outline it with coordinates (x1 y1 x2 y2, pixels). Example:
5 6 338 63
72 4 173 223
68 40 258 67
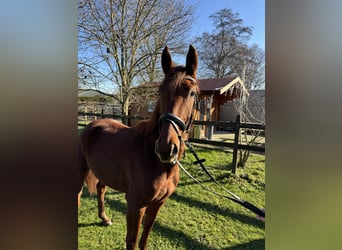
158 76 198 144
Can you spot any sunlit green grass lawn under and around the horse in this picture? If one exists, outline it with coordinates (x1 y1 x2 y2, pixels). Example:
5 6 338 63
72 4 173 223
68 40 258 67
78 147 265 250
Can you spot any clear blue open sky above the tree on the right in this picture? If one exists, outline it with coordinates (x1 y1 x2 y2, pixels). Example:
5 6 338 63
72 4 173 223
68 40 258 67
192 0 265 50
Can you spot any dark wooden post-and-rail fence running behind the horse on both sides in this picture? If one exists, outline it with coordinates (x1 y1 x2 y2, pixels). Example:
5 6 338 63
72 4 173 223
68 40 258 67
78 110 265 174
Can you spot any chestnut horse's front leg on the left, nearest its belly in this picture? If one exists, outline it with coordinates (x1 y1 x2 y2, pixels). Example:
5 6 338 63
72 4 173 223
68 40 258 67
126 200 146 250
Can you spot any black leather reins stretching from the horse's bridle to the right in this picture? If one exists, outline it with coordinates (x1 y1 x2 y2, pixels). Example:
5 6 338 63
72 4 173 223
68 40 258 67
177 141 265 218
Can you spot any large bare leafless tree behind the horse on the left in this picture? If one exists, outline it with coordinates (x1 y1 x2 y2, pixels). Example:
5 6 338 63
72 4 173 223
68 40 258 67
78 0 193 123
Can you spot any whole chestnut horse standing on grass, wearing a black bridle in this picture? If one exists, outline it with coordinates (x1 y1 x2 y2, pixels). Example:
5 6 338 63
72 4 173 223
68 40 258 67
78 45 199 249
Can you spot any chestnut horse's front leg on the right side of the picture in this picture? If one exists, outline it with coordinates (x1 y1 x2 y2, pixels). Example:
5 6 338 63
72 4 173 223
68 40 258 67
139 199 166 249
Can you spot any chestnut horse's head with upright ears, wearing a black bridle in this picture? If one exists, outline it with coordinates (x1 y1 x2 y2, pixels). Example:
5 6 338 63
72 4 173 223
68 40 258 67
155 45 199 163
